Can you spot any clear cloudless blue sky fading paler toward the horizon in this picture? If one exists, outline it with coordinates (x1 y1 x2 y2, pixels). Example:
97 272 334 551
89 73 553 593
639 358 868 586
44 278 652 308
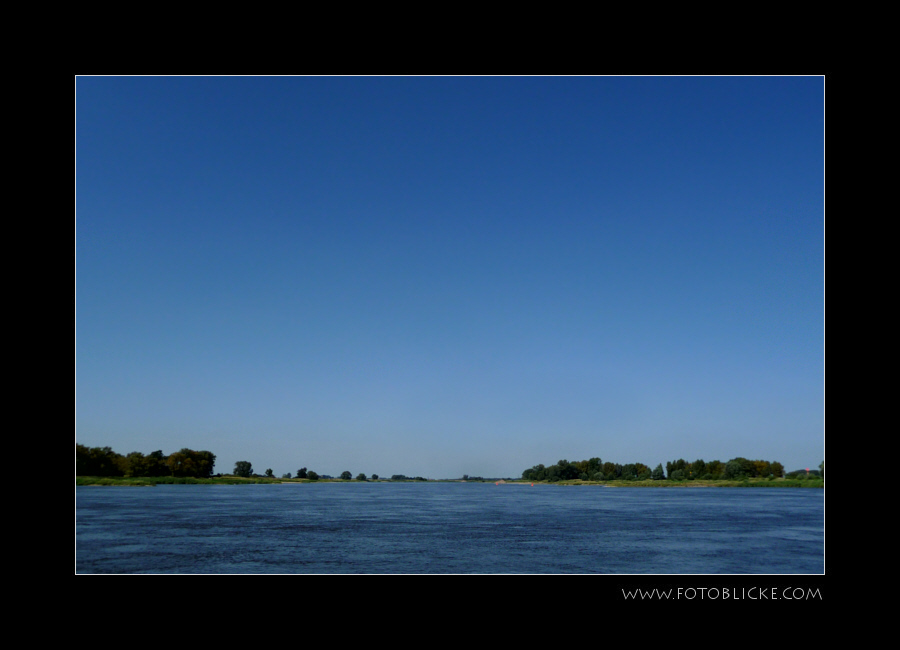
75 77 825 478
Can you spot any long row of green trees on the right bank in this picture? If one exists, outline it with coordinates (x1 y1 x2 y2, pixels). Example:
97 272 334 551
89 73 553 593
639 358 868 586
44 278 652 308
522 457 788 483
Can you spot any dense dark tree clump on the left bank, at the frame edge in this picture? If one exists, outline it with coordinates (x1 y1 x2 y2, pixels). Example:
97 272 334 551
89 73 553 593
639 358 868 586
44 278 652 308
75 444 216 478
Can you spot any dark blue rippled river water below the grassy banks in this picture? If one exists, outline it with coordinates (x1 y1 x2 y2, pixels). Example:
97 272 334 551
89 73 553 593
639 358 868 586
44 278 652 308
75 483 825 574
